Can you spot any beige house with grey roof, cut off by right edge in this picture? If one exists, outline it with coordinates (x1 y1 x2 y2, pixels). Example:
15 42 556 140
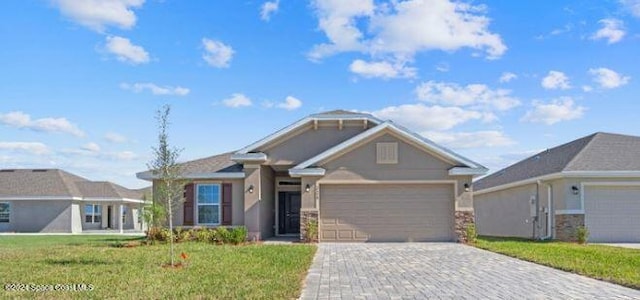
474 132 640 242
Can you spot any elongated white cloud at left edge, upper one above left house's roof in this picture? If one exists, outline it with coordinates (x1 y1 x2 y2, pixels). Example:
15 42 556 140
0 111 84 137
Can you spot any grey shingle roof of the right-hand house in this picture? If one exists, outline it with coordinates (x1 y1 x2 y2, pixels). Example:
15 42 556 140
474 132 640 191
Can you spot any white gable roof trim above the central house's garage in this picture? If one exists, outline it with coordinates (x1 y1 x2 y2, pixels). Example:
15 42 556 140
293 121 487 174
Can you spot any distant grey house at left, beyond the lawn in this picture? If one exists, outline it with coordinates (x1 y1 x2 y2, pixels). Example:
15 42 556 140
0 169 144 233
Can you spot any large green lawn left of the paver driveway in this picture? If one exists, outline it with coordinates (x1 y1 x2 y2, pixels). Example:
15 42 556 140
0 236 316 299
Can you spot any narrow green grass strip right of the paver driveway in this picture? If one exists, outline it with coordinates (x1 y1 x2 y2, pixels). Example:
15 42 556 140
475 237 640 289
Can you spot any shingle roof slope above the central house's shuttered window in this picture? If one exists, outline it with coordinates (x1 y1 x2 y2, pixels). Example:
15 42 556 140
136 152 242 180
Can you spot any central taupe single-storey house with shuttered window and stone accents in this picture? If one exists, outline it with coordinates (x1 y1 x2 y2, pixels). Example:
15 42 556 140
138 110 486 242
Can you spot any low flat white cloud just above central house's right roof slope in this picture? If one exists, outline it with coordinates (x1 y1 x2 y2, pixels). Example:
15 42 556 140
422 130 515 149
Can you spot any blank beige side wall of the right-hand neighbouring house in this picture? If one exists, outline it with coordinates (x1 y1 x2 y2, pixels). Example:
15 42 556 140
474 184 536 238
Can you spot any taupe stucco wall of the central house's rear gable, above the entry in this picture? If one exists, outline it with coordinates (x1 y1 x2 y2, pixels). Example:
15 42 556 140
260 121 365 165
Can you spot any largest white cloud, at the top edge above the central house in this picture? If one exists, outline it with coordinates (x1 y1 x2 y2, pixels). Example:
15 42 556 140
309 0 507 61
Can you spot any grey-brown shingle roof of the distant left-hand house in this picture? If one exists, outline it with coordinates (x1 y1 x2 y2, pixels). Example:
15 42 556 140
0 169 142 199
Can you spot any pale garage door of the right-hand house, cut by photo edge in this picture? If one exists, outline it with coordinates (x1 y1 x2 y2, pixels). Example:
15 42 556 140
584 186 640 242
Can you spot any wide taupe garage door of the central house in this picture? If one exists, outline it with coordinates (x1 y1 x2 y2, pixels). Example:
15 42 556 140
319 184 454 242
